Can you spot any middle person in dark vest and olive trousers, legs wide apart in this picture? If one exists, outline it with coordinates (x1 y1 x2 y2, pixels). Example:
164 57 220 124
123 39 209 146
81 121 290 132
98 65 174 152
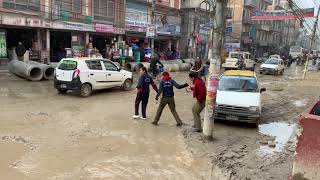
152 72 189 126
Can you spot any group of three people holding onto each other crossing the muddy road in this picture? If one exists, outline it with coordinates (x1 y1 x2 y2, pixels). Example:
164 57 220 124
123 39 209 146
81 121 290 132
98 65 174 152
133 64 206 132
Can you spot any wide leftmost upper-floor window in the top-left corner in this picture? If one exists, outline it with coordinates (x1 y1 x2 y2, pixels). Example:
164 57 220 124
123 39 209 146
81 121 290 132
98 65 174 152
3 0 40 12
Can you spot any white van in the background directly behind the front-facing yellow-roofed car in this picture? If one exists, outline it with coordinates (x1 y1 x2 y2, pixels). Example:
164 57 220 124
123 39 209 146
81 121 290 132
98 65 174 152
222 51 255 70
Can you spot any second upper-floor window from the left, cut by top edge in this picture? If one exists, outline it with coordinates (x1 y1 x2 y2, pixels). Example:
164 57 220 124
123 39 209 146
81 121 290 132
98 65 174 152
55 0 81 14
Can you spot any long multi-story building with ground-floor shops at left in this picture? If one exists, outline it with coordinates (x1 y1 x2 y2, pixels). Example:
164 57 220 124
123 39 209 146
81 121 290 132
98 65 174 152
0 0 181 67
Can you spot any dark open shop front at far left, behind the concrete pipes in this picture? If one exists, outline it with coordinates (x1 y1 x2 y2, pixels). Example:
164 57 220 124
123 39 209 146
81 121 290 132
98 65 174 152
0 14 51 65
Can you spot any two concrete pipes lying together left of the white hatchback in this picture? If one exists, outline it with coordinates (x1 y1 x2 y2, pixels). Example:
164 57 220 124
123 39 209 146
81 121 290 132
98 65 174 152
8 60 54 81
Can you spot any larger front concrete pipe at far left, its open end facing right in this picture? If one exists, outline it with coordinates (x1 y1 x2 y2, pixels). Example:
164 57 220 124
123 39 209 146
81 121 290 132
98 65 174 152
8 60 43 81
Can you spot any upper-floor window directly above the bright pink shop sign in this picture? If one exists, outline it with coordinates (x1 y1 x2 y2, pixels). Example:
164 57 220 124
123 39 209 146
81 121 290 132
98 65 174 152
93 0 115 22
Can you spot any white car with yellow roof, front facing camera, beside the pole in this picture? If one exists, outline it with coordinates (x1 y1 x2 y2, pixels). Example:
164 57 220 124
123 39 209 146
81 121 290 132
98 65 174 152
214 70 266 124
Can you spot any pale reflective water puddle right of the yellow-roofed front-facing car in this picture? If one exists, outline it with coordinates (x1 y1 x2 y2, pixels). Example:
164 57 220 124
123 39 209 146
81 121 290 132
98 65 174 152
258 122 296 156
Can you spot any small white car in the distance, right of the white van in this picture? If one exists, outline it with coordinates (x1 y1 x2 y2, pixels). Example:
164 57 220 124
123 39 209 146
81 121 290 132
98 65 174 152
260 58 285 75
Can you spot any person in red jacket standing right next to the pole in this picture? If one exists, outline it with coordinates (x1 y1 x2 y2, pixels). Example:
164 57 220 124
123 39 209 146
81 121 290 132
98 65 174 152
189 72 207 132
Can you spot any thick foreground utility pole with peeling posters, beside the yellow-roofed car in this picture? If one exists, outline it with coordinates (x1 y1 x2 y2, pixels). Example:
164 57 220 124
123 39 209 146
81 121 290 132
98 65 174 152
203 0 227 139
